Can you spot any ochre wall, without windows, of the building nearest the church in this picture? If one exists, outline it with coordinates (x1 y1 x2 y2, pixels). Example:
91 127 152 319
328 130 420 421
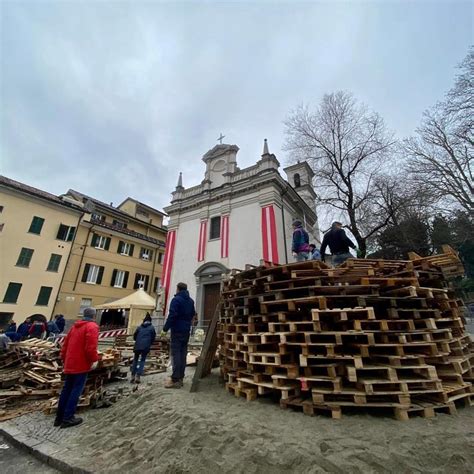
55 216 166 319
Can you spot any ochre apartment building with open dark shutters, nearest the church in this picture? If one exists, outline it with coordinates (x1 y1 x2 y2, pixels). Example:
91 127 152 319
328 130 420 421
54 189 167 319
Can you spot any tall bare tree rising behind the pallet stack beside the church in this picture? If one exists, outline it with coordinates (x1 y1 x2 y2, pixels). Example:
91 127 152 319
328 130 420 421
285 91 394 256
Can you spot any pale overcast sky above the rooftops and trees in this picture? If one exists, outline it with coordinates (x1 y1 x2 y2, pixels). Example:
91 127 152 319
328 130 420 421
0 0 473 215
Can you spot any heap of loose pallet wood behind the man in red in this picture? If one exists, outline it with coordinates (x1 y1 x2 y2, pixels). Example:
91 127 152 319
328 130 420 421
0 339 120 421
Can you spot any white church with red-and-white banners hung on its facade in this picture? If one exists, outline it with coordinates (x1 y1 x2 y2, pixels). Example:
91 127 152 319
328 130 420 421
162 140 320 326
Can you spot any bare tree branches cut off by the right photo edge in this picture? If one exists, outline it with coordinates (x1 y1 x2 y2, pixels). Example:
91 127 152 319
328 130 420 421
404 48 474 213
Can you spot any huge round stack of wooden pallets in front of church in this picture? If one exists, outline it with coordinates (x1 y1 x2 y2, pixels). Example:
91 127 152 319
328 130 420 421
219 248 474 419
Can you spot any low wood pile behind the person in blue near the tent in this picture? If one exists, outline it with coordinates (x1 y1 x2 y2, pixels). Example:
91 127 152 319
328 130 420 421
115 336 170 375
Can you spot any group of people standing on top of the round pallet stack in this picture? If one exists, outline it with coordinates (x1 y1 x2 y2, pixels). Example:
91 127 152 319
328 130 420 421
291 220 356 265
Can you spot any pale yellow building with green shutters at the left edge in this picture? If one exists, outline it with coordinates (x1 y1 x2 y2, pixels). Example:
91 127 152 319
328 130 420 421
0 176 83 327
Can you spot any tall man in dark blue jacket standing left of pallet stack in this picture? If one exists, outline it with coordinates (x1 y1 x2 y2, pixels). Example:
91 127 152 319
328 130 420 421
163 283 196 388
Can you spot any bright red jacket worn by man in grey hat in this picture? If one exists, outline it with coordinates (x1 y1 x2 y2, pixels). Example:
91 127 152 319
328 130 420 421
61 320 99 374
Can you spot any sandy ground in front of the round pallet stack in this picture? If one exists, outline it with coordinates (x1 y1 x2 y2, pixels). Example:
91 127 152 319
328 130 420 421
4 370 474 473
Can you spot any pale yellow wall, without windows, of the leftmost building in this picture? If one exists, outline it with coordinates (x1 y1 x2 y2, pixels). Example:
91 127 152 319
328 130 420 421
0 188 80 323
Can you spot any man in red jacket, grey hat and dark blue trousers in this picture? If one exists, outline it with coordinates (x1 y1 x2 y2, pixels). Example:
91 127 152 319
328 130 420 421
54 308 99 428
